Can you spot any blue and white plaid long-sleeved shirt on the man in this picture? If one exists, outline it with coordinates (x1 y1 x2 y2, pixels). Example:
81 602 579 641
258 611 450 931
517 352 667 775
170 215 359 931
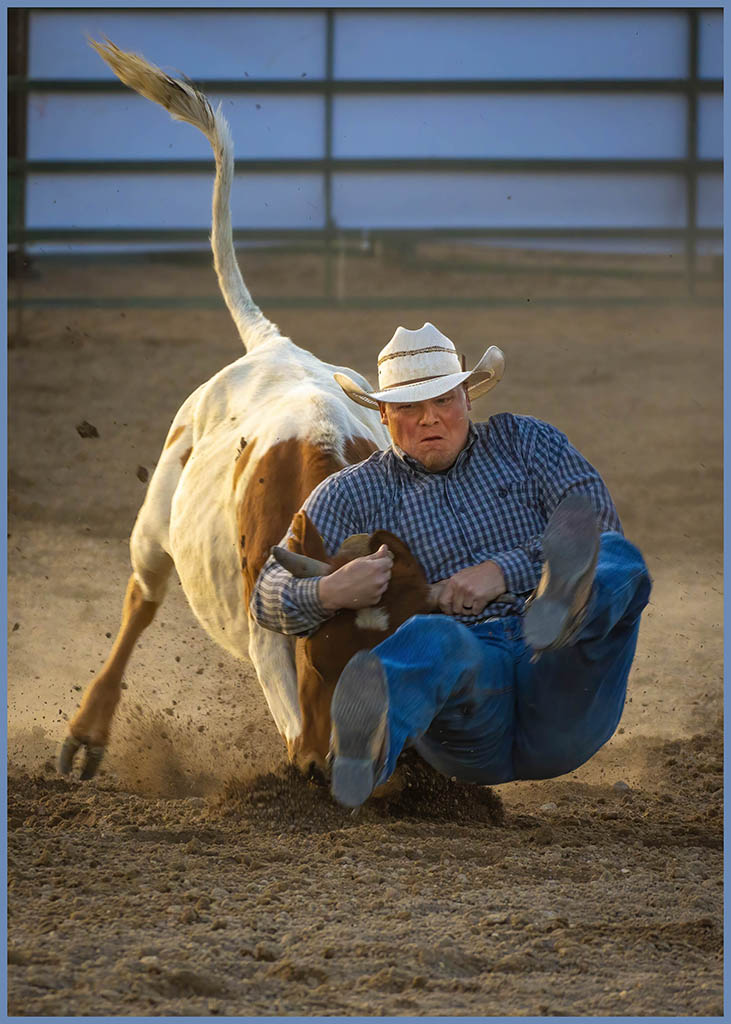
251 413 621 636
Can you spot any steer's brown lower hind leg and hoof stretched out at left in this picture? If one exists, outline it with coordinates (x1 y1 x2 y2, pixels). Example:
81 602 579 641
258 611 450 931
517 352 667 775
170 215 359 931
58 538 173 779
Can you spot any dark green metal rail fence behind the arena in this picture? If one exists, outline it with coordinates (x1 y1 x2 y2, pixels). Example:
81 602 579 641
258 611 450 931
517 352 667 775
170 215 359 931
8 9 723 305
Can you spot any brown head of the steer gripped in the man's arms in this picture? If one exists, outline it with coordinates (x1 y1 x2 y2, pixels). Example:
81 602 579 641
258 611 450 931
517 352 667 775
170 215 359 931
288 512 432 768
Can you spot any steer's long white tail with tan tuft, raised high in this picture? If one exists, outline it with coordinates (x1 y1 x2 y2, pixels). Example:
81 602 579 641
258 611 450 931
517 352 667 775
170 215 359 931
89 39 278 350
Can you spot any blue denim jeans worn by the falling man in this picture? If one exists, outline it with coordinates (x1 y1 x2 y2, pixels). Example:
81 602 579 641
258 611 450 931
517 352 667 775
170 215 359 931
374 532 651 785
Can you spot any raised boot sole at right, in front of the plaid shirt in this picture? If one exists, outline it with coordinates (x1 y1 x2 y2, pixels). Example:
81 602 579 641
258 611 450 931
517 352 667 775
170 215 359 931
523 495 599 650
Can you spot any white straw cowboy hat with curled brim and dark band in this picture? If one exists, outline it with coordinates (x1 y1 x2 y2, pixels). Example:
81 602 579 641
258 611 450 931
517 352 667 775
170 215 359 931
335 323 505 409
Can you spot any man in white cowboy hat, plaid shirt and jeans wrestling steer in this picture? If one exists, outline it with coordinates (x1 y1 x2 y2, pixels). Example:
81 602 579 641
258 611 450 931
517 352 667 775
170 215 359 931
252 324 650 807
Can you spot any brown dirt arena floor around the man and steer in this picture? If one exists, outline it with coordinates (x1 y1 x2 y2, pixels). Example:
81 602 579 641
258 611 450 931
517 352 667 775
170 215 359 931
8 253 723 1017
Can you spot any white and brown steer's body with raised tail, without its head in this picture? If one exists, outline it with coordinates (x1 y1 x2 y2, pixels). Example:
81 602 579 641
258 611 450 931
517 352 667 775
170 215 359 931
59 40 388 778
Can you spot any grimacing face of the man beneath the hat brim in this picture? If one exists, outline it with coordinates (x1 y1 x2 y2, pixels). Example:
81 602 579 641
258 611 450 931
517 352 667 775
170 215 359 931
379 384 472 473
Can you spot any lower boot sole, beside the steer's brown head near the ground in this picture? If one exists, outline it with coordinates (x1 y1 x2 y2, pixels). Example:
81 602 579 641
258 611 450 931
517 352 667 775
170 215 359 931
330 651 388 807
